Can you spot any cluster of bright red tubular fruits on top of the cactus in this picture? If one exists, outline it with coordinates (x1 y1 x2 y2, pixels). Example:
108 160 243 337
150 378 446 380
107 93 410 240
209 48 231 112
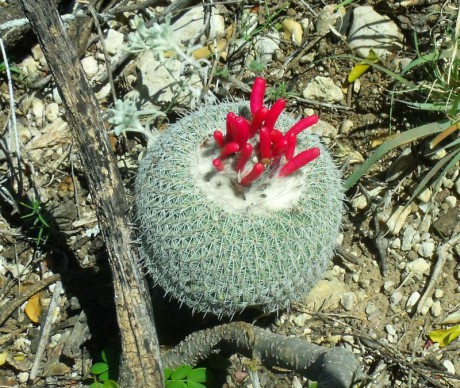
213 77 320 186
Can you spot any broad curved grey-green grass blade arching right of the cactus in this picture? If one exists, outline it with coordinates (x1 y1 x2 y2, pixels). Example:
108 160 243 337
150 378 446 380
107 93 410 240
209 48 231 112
344 121 451 190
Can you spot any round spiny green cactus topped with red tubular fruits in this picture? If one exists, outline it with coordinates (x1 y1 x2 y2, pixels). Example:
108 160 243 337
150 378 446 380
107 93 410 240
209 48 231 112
136 78 343 316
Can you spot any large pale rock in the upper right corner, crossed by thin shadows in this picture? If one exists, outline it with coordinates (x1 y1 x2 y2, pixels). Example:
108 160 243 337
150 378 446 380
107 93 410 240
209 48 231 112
348 6 403 58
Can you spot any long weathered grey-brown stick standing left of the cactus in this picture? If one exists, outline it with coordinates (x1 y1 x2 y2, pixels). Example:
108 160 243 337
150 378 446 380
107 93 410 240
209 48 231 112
20 0 164 387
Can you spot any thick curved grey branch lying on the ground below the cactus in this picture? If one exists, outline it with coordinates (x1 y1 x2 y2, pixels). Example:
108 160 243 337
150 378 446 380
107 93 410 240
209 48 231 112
162 322 361 388
